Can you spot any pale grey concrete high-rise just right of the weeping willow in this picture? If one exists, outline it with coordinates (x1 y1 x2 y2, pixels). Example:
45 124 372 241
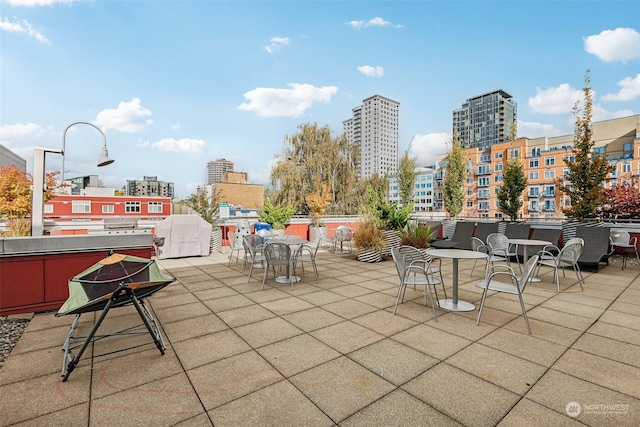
342 95 400 179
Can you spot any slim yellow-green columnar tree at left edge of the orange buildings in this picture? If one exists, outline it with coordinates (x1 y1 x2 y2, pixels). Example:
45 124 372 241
442 129 465 218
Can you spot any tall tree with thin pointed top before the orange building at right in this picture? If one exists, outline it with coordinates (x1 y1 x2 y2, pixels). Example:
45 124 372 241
558 70 613 221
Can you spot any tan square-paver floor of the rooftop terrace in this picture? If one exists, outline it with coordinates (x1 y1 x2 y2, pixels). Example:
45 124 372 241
0 249 640 426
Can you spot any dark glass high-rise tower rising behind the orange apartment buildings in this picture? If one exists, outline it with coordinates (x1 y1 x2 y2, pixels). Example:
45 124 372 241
453 89 518 150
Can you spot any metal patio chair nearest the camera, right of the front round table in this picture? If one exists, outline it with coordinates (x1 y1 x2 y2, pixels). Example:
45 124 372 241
476 255 538 335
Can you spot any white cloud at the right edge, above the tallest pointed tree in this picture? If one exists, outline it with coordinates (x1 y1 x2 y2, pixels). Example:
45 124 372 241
584 28 640 62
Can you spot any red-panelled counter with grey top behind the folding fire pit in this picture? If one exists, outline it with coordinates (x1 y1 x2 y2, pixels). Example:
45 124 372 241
0 233 153 316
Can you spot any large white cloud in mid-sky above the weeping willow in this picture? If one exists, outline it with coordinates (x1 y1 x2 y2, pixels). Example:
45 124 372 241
238 83 338 118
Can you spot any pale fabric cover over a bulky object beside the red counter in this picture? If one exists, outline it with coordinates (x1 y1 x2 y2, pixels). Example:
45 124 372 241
156 215 213 259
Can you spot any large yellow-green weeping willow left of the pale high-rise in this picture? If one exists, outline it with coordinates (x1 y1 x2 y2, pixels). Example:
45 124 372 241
270 123 359 214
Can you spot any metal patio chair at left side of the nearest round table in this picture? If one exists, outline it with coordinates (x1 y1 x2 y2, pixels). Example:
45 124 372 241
391 246 447 322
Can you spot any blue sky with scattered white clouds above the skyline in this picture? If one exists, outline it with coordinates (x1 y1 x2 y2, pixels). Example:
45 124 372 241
0 0 640 198
